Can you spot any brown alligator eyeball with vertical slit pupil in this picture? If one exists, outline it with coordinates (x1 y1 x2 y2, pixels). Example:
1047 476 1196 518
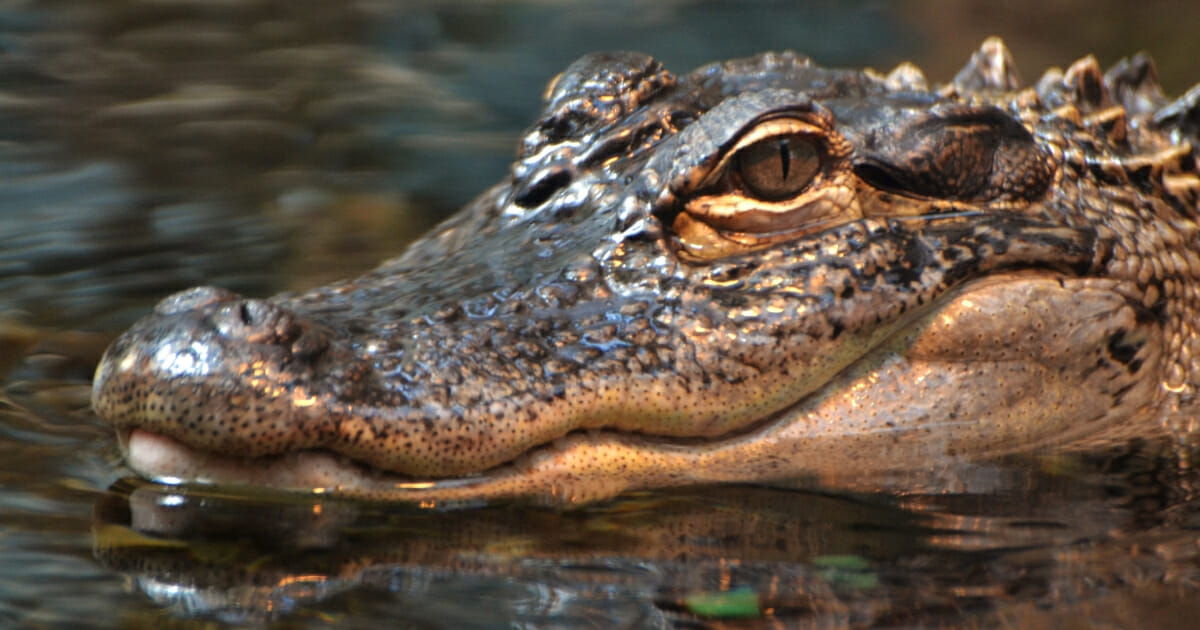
737 136 821 202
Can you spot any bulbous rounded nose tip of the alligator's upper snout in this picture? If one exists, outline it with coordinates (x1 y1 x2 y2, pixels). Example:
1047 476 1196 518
92 287 348 463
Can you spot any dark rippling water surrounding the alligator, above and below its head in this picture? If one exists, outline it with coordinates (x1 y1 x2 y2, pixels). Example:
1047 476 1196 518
0 0 1200 628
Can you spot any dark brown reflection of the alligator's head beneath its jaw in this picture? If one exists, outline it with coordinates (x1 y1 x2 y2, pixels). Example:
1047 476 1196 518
95 452 1200 628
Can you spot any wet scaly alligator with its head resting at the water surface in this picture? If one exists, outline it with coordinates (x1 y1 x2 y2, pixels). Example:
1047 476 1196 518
92 38 1200 504
